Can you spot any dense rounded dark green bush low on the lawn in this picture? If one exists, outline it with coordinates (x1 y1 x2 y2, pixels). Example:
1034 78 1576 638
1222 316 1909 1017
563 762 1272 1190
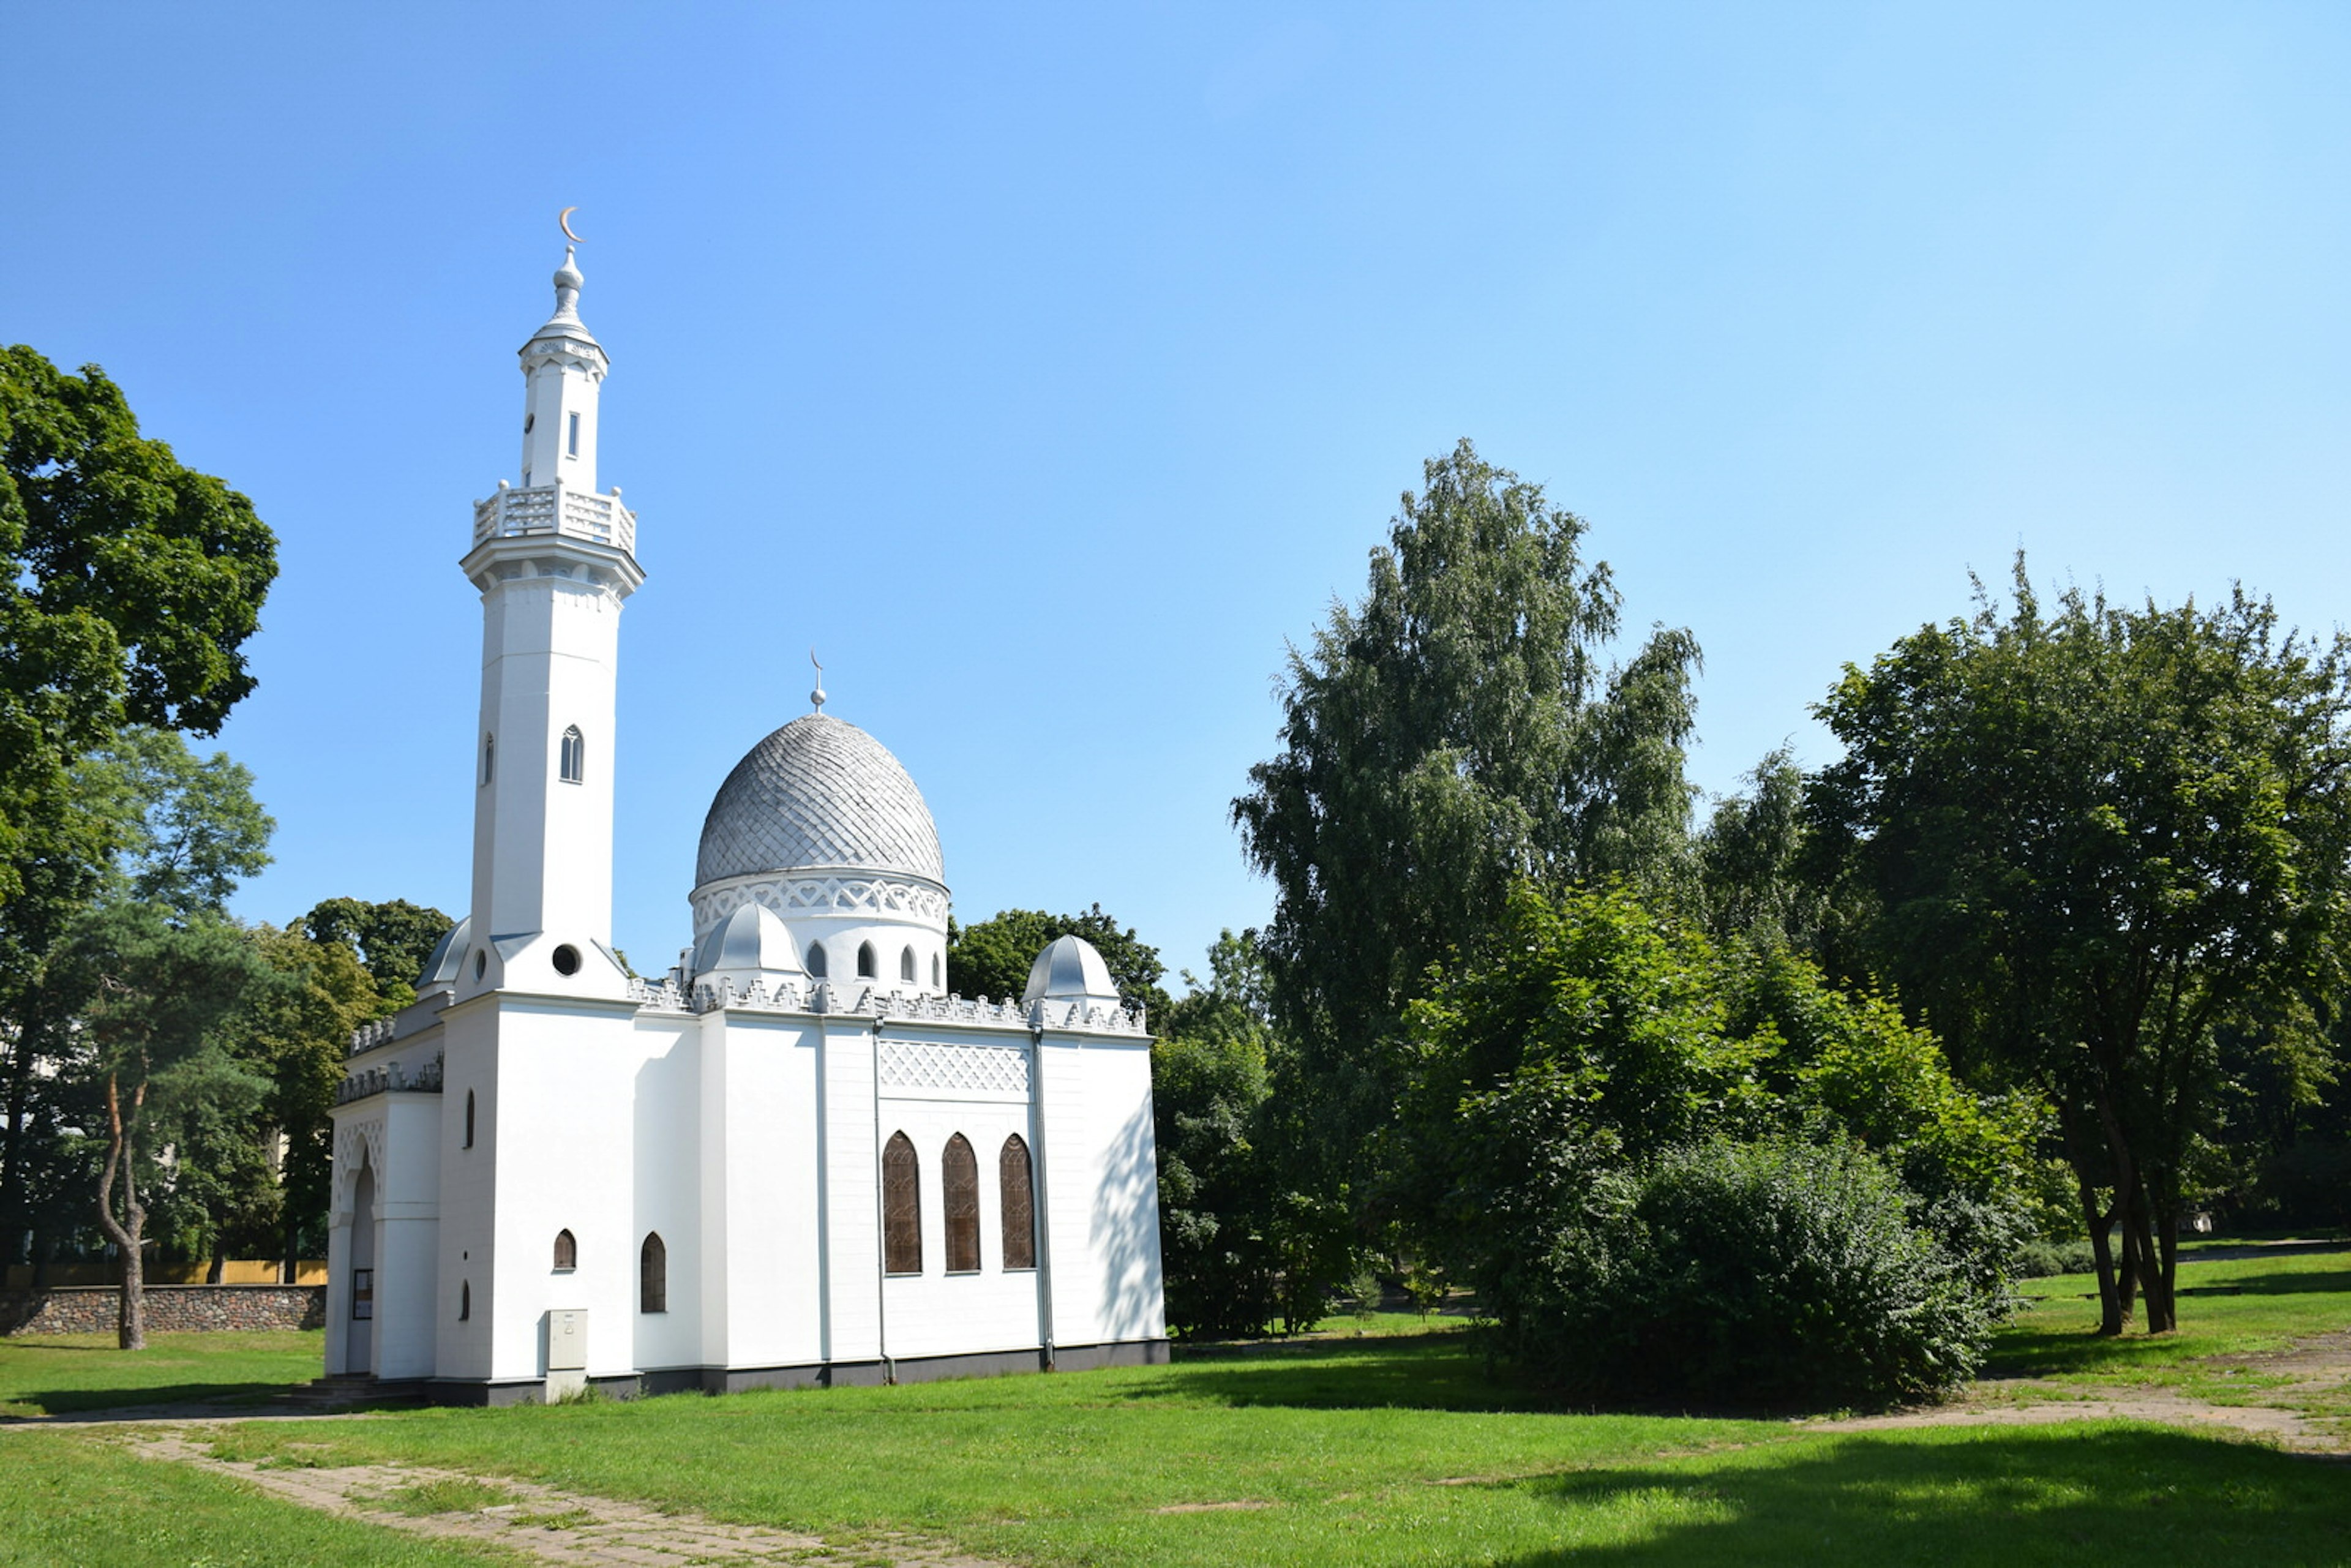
1483 1138 2008 1408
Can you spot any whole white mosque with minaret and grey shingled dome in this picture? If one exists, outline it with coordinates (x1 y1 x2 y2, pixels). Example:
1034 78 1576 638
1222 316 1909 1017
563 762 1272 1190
327 236 1166 1403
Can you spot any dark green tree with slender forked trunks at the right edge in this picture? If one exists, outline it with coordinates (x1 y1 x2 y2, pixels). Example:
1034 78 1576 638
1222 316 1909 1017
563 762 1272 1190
1810 555 2351 1333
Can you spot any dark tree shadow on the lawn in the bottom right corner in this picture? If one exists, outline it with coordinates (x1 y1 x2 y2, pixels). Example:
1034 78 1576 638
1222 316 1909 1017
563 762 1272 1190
1495 1422 2351 1568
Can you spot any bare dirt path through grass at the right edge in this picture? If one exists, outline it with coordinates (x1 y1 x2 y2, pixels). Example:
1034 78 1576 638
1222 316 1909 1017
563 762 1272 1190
1803 1330 2351 1455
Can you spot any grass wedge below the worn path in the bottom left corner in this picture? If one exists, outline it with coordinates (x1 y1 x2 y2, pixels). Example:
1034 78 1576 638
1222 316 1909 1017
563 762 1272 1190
0 1431 515 1568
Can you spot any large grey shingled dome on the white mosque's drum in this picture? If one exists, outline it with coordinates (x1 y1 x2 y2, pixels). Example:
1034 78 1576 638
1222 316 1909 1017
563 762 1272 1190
694 712 945 887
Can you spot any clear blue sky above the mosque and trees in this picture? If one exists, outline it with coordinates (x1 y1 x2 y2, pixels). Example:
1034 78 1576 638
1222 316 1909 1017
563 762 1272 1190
0 5 2351 987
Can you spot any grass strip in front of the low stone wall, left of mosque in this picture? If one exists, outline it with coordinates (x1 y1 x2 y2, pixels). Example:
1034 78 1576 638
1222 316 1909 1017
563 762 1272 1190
0 1328 327 1415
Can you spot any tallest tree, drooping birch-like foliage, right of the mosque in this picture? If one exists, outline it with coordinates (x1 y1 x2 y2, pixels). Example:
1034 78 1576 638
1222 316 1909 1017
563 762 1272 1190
1232 442 1697 1213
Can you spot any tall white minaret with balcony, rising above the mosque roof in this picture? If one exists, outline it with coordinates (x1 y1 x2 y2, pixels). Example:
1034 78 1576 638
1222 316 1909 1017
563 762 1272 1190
456 249 644 997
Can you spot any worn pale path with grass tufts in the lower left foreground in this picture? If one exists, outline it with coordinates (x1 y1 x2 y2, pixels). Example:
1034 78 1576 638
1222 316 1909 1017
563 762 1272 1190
112 1429 1004 1568
